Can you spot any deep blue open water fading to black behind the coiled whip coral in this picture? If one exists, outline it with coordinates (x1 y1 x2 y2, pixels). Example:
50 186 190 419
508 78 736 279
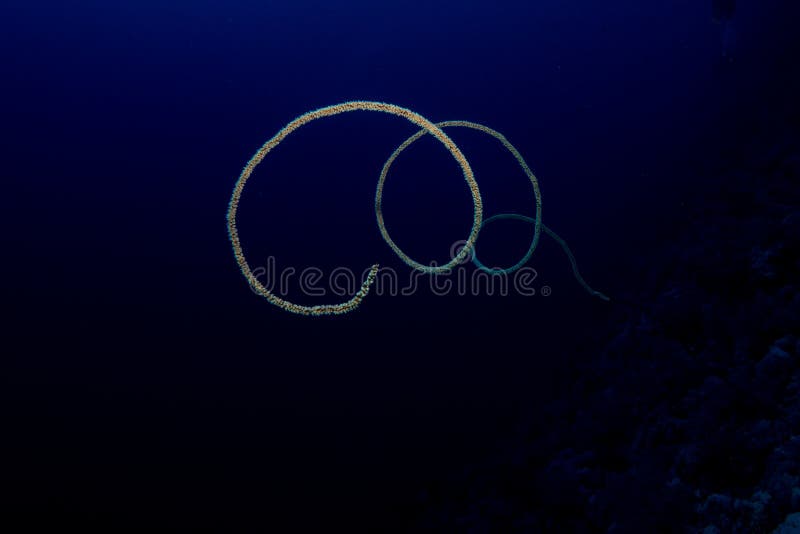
0 0 798 528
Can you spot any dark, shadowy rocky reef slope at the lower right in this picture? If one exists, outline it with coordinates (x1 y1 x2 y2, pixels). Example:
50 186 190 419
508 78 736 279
415 119 800 533
